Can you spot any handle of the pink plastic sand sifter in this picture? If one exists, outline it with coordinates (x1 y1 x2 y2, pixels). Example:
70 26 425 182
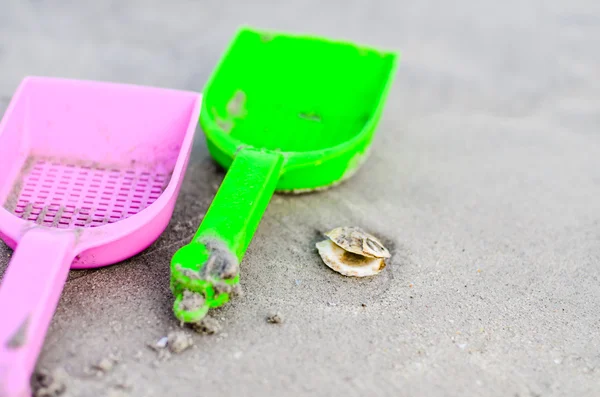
0 228 76 397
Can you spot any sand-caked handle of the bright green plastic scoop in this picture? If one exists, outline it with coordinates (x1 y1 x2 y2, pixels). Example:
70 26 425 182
171 149 284 323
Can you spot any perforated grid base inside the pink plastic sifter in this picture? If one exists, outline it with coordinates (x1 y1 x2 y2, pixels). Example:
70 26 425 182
5 157 170 229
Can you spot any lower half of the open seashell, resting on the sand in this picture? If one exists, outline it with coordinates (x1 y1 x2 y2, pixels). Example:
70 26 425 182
316 240 385 277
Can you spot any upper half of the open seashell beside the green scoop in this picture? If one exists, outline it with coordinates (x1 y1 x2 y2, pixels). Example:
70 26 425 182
325 226 391 258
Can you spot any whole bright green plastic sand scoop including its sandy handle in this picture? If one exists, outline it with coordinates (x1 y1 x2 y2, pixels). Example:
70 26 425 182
171 28 398 323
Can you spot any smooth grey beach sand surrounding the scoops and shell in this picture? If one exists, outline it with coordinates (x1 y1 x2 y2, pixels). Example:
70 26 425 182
0 0 600 397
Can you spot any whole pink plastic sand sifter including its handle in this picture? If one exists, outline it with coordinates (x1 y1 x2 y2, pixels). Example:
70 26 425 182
0 77 201 397
